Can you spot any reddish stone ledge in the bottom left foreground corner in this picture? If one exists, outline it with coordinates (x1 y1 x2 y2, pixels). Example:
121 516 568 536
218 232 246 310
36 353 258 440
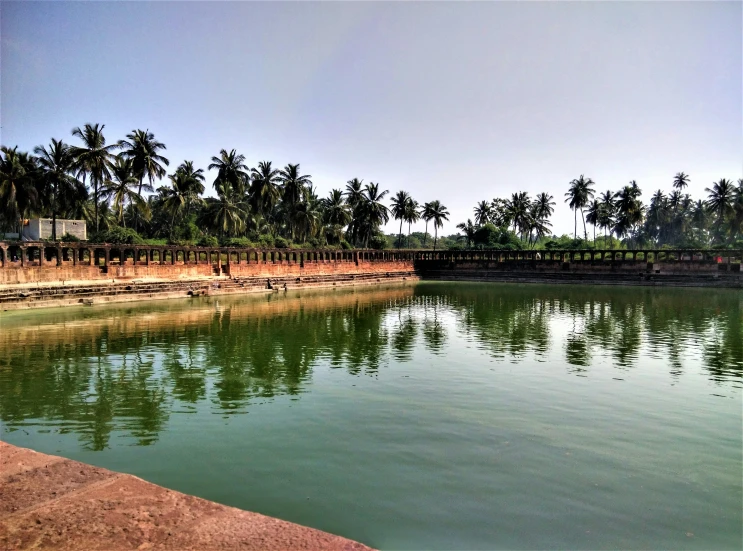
0 442 370 551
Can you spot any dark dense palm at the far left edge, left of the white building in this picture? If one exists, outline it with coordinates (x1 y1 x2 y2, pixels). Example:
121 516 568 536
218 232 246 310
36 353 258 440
0 146 41 236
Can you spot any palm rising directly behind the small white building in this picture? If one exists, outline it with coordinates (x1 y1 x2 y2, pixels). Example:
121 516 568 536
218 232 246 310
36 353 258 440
34 138 88 241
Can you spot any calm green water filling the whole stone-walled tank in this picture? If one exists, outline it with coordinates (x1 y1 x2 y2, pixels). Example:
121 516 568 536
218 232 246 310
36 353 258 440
0 283 743 549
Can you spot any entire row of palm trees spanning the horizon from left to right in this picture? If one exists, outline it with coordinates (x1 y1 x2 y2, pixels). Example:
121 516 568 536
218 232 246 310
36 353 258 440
0 124 743 248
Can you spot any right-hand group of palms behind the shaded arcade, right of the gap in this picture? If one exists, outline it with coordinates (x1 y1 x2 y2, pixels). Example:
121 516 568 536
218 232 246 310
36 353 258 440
457 172 743 248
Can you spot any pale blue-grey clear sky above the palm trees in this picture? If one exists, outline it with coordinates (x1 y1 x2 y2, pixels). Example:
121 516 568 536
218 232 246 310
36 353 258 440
0 0 743 234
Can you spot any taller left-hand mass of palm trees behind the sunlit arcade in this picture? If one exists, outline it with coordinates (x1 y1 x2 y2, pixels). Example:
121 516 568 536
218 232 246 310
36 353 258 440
0 124 449 248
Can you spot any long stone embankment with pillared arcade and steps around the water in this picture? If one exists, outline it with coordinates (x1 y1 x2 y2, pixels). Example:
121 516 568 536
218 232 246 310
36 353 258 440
0 242 743 310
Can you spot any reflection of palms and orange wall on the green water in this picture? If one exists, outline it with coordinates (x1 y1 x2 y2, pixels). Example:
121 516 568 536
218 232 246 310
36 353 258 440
0 284 743 450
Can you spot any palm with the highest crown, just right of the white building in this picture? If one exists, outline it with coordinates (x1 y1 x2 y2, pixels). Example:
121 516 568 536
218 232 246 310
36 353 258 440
72 123 118 232
